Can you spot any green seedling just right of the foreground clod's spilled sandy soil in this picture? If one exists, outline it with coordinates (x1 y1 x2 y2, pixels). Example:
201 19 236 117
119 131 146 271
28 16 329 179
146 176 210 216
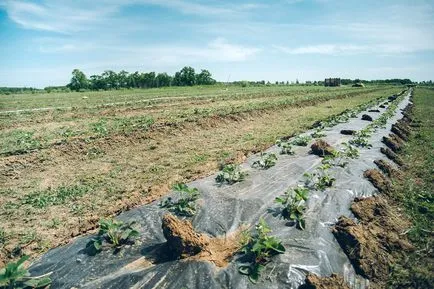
238 218 285 283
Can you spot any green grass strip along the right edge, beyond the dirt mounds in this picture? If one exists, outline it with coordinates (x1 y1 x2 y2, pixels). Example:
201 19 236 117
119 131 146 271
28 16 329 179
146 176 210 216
389 88 434 288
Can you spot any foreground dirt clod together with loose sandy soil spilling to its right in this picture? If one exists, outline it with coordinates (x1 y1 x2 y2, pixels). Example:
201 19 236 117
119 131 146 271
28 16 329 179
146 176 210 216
162 214 240 267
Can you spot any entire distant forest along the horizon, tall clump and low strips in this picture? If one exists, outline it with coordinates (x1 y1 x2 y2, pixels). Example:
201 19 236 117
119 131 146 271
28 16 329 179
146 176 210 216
0 66 433 94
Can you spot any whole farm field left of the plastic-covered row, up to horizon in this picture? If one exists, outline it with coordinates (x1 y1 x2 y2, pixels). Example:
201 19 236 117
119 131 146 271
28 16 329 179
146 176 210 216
0 86 402 262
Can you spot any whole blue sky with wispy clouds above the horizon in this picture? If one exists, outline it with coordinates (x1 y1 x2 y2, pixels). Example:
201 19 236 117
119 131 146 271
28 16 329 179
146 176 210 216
0 0 434 87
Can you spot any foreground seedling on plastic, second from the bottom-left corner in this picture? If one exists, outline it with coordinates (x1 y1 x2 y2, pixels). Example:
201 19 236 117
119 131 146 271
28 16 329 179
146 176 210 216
87 219 139 255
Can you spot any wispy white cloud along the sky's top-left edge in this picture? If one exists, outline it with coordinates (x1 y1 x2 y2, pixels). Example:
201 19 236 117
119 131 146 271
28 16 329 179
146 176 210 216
0 0 251 34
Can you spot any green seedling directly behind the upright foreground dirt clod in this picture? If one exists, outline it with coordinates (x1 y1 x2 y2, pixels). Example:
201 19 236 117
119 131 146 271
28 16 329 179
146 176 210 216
160 184 199 217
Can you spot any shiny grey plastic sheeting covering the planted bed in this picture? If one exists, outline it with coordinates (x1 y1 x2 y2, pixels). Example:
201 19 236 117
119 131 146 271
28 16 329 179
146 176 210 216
30 90 409 289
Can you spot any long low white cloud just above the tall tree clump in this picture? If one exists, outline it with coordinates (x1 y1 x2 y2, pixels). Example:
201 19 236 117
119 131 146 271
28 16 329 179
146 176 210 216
36 38 261 69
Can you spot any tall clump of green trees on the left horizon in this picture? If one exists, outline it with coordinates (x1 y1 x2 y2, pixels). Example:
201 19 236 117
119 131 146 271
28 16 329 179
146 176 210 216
67 66 216 91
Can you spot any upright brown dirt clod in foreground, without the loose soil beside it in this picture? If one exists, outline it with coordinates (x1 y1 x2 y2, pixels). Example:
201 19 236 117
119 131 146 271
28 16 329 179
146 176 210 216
162 214 209 258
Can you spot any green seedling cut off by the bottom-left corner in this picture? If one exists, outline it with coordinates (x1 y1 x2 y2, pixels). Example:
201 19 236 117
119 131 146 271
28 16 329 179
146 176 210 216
0 256 51 289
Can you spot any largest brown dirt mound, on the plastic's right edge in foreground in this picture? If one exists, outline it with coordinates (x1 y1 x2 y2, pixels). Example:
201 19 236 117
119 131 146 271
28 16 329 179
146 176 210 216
332 196 414 284
